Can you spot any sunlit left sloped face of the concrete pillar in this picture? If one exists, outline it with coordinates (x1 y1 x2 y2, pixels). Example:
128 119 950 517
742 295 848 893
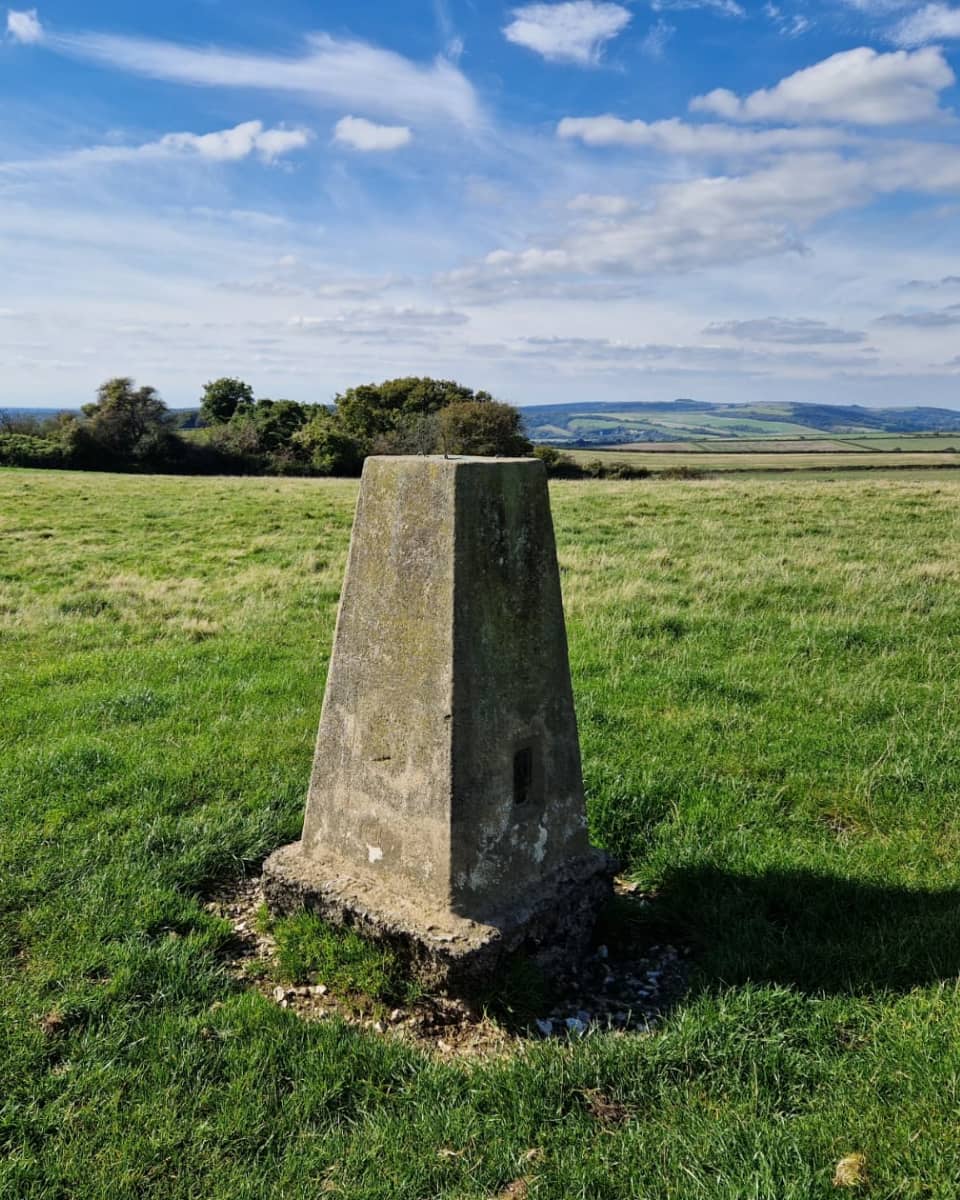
302 457 455 902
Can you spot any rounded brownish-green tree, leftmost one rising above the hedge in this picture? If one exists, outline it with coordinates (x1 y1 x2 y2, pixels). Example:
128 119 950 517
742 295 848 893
82 376 176 462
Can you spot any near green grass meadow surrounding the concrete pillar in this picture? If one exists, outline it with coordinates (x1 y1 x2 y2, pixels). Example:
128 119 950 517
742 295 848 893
0 470 960 1200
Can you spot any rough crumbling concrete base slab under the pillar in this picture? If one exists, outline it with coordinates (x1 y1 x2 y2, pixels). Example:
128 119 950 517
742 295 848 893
263 842 616 995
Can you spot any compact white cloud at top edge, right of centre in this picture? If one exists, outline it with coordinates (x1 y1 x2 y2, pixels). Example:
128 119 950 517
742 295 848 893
503 0 631 66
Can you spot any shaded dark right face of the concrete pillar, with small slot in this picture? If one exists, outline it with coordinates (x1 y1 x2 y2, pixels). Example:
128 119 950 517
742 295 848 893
450 460 589 917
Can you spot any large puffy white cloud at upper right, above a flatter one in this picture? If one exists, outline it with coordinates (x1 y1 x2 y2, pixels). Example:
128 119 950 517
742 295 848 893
690 46 956 125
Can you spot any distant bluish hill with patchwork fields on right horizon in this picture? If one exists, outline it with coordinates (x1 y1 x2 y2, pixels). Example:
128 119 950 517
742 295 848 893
521 400 960 446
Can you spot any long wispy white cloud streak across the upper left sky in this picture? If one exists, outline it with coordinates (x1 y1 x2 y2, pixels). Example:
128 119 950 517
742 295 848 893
46 34 481 126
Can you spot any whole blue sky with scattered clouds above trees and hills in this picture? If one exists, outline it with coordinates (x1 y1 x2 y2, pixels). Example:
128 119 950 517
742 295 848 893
0 0 960 407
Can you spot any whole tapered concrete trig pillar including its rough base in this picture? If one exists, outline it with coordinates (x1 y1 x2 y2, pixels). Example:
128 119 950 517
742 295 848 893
264 457 612 988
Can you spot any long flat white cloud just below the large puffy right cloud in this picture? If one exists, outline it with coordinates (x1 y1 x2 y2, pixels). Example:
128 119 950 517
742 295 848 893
557 114 851 157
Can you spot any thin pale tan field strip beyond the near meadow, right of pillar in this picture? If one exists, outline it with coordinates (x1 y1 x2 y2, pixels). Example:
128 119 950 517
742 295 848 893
571 439 960 474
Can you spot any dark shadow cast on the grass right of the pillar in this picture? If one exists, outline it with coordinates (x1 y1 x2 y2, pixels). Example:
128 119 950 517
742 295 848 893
637 866 960 995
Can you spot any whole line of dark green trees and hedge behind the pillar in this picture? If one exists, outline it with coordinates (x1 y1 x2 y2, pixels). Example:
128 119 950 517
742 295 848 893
0 377 533 475
